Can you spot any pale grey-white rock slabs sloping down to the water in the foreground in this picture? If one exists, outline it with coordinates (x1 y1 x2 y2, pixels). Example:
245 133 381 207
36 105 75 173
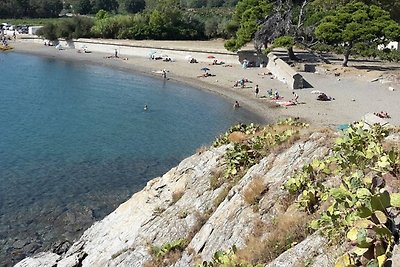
16 133 368 267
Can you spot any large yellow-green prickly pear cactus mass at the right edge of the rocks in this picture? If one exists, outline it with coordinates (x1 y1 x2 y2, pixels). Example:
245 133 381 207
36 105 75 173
285 122 400 266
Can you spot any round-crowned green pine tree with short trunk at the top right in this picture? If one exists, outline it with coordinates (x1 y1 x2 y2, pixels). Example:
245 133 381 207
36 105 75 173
315 2 400 67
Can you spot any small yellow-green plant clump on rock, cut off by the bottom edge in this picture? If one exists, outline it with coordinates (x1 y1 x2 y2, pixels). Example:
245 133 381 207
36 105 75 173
196 246 263 267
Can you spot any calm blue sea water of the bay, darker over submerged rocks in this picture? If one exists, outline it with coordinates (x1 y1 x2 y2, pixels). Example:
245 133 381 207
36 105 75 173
0 53 264 266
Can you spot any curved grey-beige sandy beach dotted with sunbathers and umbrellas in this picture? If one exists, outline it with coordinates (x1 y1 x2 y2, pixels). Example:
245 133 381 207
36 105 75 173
11 41 400 128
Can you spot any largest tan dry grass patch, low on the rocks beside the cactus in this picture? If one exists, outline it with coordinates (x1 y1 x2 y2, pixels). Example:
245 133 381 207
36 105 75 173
238 212 311 264
